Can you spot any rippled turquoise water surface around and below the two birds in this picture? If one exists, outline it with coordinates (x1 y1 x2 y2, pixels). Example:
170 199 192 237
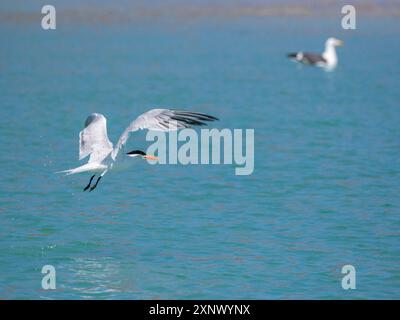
0 17 400 299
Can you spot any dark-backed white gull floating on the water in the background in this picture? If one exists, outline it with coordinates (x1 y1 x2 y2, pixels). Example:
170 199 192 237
288 38 343 69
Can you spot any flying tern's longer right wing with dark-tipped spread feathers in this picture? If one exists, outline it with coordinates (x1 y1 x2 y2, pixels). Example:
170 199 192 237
112 109 218 159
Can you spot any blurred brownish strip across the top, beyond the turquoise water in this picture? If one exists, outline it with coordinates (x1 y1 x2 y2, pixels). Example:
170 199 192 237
0 0 400 23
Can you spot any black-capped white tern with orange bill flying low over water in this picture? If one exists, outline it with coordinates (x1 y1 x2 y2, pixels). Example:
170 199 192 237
57 109 218 191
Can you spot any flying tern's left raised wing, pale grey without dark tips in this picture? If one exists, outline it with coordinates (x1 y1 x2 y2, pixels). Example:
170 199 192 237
79 113 113 163
